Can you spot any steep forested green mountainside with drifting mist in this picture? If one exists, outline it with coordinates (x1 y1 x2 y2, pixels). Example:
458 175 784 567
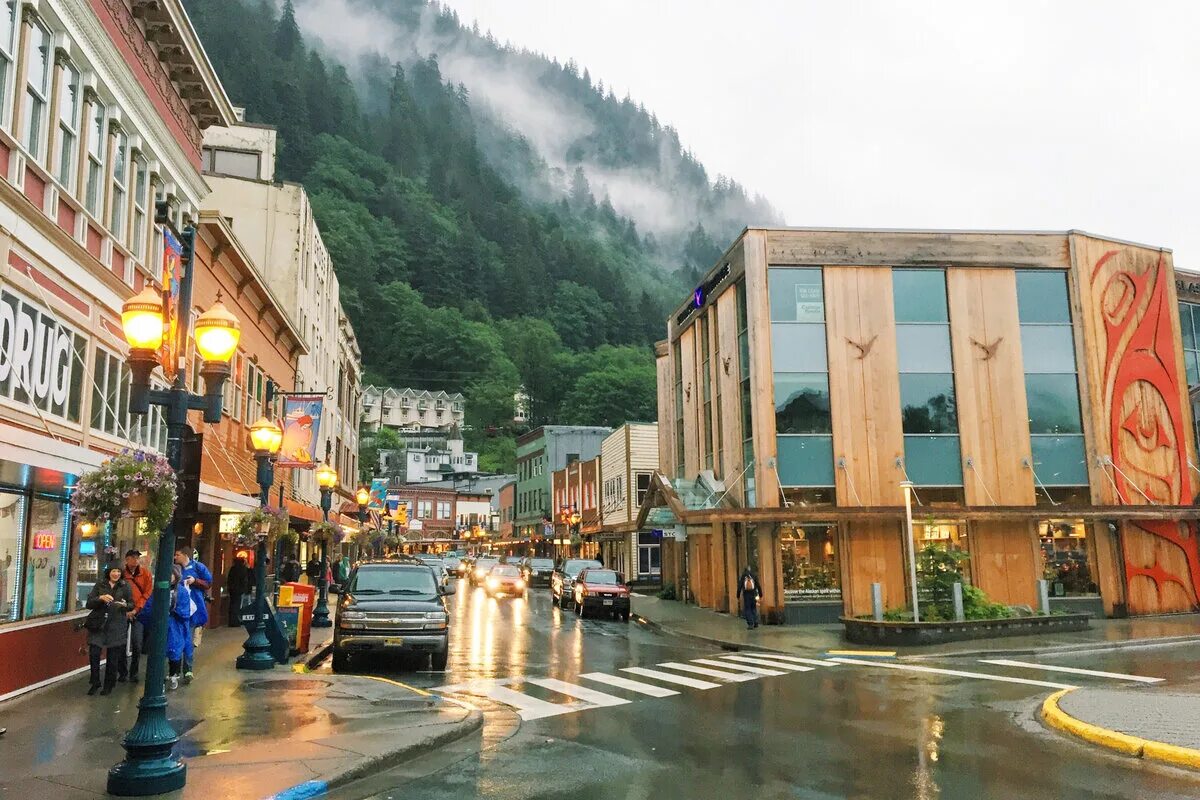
178 0 776 469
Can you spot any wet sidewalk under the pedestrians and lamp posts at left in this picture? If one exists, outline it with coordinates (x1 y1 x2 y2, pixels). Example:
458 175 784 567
0 628 482 800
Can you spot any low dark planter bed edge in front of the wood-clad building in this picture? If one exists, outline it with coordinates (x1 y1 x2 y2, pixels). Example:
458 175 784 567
841 614 1092 648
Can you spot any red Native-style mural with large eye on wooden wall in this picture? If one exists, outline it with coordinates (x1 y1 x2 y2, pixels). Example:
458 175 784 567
1092 249 1200 603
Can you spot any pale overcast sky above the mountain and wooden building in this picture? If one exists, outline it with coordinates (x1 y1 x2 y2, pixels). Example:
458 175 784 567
445 0 1200 269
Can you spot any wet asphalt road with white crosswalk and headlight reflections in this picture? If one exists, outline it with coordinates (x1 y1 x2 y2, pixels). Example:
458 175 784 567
316 584 1200 800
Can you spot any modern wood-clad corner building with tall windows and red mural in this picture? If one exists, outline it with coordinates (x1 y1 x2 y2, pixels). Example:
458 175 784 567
638 228 1200 621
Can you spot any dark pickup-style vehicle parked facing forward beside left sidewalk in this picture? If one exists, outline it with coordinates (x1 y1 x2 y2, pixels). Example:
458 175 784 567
334 557 454 670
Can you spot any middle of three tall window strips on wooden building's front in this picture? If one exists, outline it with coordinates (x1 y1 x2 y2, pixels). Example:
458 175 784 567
892 269 962 486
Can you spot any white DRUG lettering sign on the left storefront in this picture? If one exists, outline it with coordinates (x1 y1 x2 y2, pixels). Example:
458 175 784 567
0 290 86 421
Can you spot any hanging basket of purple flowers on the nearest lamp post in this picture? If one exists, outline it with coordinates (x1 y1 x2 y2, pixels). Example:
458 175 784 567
71 450 178 533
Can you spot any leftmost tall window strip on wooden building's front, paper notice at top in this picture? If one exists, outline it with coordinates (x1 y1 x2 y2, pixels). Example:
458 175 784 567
772 267 834 487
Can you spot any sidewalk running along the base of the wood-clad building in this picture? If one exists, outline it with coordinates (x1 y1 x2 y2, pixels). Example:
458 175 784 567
632 595 1200 658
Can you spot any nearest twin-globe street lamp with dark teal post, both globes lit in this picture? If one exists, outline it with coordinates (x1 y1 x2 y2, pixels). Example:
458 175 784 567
108 203 240 796
